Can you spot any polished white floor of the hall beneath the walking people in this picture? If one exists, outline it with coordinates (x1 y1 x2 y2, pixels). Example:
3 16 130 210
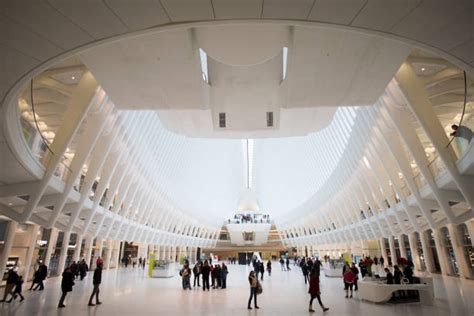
0 264 474 316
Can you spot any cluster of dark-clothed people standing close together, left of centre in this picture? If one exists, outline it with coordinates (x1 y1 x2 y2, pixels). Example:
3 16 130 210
180 260 229 291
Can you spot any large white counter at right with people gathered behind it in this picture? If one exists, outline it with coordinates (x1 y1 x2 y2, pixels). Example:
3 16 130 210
358 281 434 305
